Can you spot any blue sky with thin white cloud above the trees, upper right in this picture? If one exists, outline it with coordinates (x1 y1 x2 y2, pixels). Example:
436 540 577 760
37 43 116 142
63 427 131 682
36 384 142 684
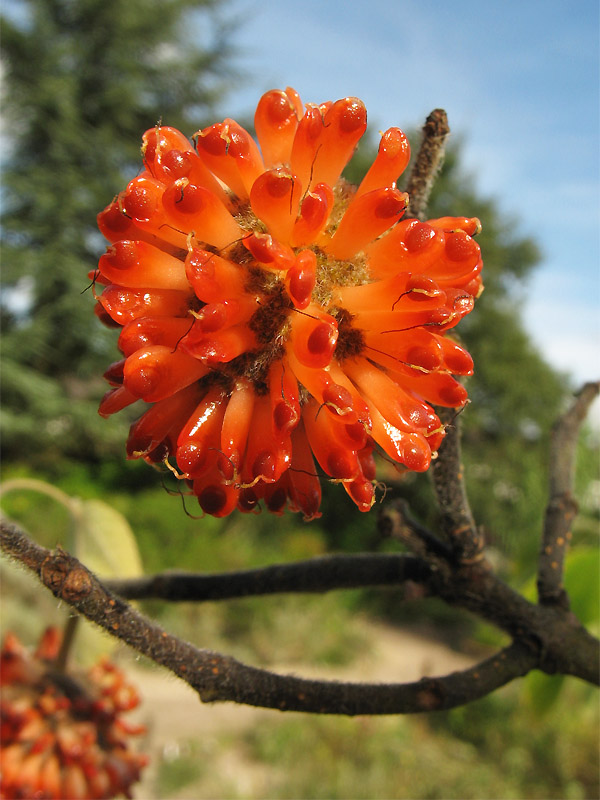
223 0 600 404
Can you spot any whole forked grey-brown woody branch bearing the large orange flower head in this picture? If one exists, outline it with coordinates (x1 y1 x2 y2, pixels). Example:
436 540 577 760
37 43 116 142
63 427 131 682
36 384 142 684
2 112 599 714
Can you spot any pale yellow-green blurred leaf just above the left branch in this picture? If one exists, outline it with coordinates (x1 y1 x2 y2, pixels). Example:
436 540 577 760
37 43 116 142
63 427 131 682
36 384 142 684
75 500 143 578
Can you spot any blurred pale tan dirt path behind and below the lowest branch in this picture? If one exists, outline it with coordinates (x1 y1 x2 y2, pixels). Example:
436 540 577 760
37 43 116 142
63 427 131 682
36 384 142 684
128 622 478 800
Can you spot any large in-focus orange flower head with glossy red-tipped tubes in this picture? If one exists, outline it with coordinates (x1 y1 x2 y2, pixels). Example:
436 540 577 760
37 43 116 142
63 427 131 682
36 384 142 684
94 88 482 519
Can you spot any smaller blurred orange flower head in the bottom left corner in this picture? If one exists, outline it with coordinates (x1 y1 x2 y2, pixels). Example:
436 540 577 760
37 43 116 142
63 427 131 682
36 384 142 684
0 628 147 800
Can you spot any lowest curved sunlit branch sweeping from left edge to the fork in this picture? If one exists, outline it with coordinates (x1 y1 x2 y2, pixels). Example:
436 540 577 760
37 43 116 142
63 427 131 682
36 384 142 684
2 523 536 716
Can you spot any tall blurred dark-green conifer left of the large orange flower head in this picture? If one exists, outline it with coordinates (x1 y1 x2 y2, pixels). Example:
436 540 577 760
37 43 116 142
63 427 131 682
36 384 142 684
2 0 231 456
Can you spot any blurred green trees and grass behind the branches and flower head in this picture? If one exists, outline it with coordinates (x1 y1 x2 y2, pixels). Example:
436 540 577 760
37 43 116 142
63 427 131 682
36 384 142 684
1 0 600 798
